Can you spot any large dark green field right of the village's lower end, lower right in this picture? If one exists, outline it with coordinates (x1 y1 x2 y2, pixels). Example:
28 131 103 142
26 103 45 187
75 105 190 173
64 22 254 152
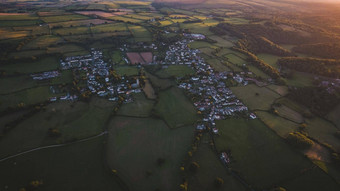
216 119 334 190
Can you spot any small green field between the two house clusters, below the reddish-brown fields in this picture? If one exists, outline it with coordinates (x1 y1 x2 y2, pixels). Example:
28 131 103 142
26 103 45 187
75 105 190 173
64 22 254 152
156 65 195 78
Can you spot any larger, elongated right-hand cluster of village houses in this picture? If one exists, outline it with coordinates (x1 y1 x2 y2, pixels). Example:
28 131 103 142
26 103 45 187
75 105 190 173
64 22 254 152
165 39 256 134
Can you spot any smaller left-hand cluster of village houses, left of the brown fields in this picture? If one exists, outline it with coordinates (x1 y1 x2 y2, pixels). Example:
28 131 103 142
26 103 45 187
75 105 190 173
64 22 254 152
50 49 141 103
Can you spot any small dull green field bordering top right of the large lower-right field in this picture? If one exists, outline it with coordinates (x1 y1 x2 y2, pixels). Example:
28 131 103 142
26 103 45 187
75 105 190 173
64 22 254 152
256 111 299 137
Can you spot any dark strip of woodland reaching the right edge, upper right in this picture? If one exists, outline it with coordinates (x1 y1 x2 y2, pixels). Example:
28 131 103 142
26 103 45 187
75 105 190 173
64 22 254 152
277 57 340 78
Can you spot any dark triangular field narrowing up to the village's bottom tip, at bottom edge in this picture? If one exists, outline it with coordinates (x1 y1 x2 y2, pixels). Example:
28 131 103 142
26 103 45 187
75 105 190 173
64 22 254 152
188 134 246 191
